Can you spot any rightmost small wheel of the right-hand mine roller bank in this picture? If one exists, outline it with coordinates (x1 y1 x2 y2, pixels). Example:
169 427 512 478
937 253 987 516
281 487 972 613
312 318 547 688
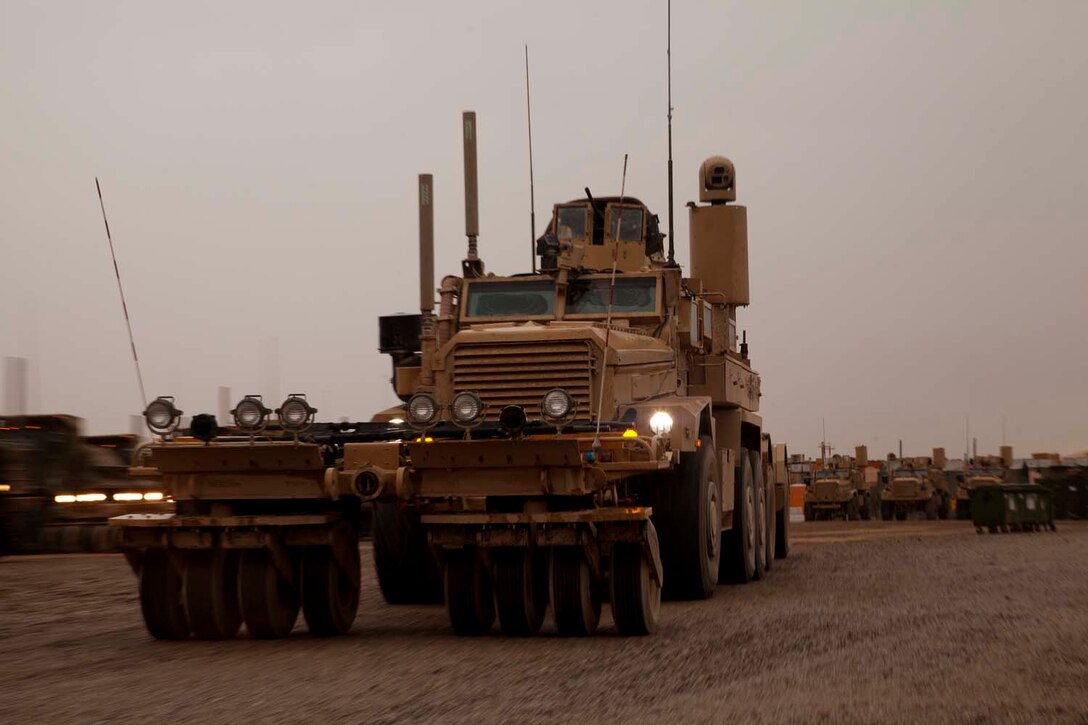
608 521 662 636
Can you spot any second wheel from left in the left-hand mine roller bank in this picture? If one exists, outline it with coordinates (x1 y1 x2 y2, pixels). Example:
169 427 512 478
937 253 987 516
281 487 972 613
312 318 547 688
184 549 242 639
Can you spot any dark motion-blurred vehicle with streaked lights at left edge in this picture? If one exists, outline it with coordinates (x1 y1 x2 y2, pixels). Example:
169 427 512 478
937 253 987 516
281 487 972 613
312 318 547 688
0 415 171 554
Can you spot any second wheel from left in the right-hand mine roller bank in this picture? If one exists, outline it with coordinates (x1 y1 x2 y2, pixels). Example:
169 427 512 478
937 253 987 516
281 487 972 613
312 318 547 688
491 548 548 637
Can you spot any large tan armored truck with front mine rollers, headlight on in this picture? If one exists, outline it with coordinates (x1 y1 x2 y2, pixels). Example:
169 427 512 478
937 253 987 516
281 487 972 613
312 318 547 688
115 113 789 638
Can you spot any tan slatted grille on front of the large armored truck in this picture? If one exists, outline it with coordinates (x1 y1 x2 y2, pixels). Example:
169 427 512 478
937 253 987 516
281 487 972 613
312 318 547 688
454 341 593 420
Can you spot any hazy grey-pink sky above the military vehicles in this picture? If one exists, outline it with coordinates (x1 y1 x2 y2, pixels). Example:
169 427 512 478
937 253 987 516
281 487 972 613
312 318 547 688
0 0 1088 455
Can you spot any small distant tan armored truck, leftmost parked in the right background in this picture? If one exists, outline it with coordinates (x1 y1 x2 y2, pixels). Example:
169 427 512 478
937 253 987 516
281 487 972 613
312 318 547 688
804 445 876 521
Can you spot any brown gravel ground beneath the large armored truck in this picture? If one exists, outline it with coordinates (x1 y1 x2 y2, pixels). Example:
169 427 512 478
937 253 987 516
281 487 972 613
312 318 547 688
0 521 1088 723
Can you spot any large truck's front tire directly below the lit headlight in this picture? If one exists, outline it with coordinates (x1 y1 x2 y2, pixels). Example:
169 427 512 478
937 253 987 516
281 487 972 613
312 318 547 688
654 435 721 599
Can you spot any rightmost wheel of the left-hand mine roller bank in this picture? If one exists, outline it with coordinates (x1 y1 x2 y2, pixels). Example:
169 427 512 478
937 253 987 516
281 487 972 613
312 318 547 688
302 529 359 637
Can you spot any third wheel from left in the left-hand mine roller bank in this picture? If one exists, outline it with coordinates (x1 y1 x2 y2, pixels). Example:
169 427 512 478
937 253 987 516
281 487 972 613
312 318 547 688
238 549 299 639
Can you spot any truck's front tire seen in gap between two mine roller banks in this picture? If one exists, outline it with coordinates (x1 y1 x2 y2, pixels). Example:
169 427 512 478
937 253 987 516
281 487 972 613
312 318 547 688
372 501 443 604
